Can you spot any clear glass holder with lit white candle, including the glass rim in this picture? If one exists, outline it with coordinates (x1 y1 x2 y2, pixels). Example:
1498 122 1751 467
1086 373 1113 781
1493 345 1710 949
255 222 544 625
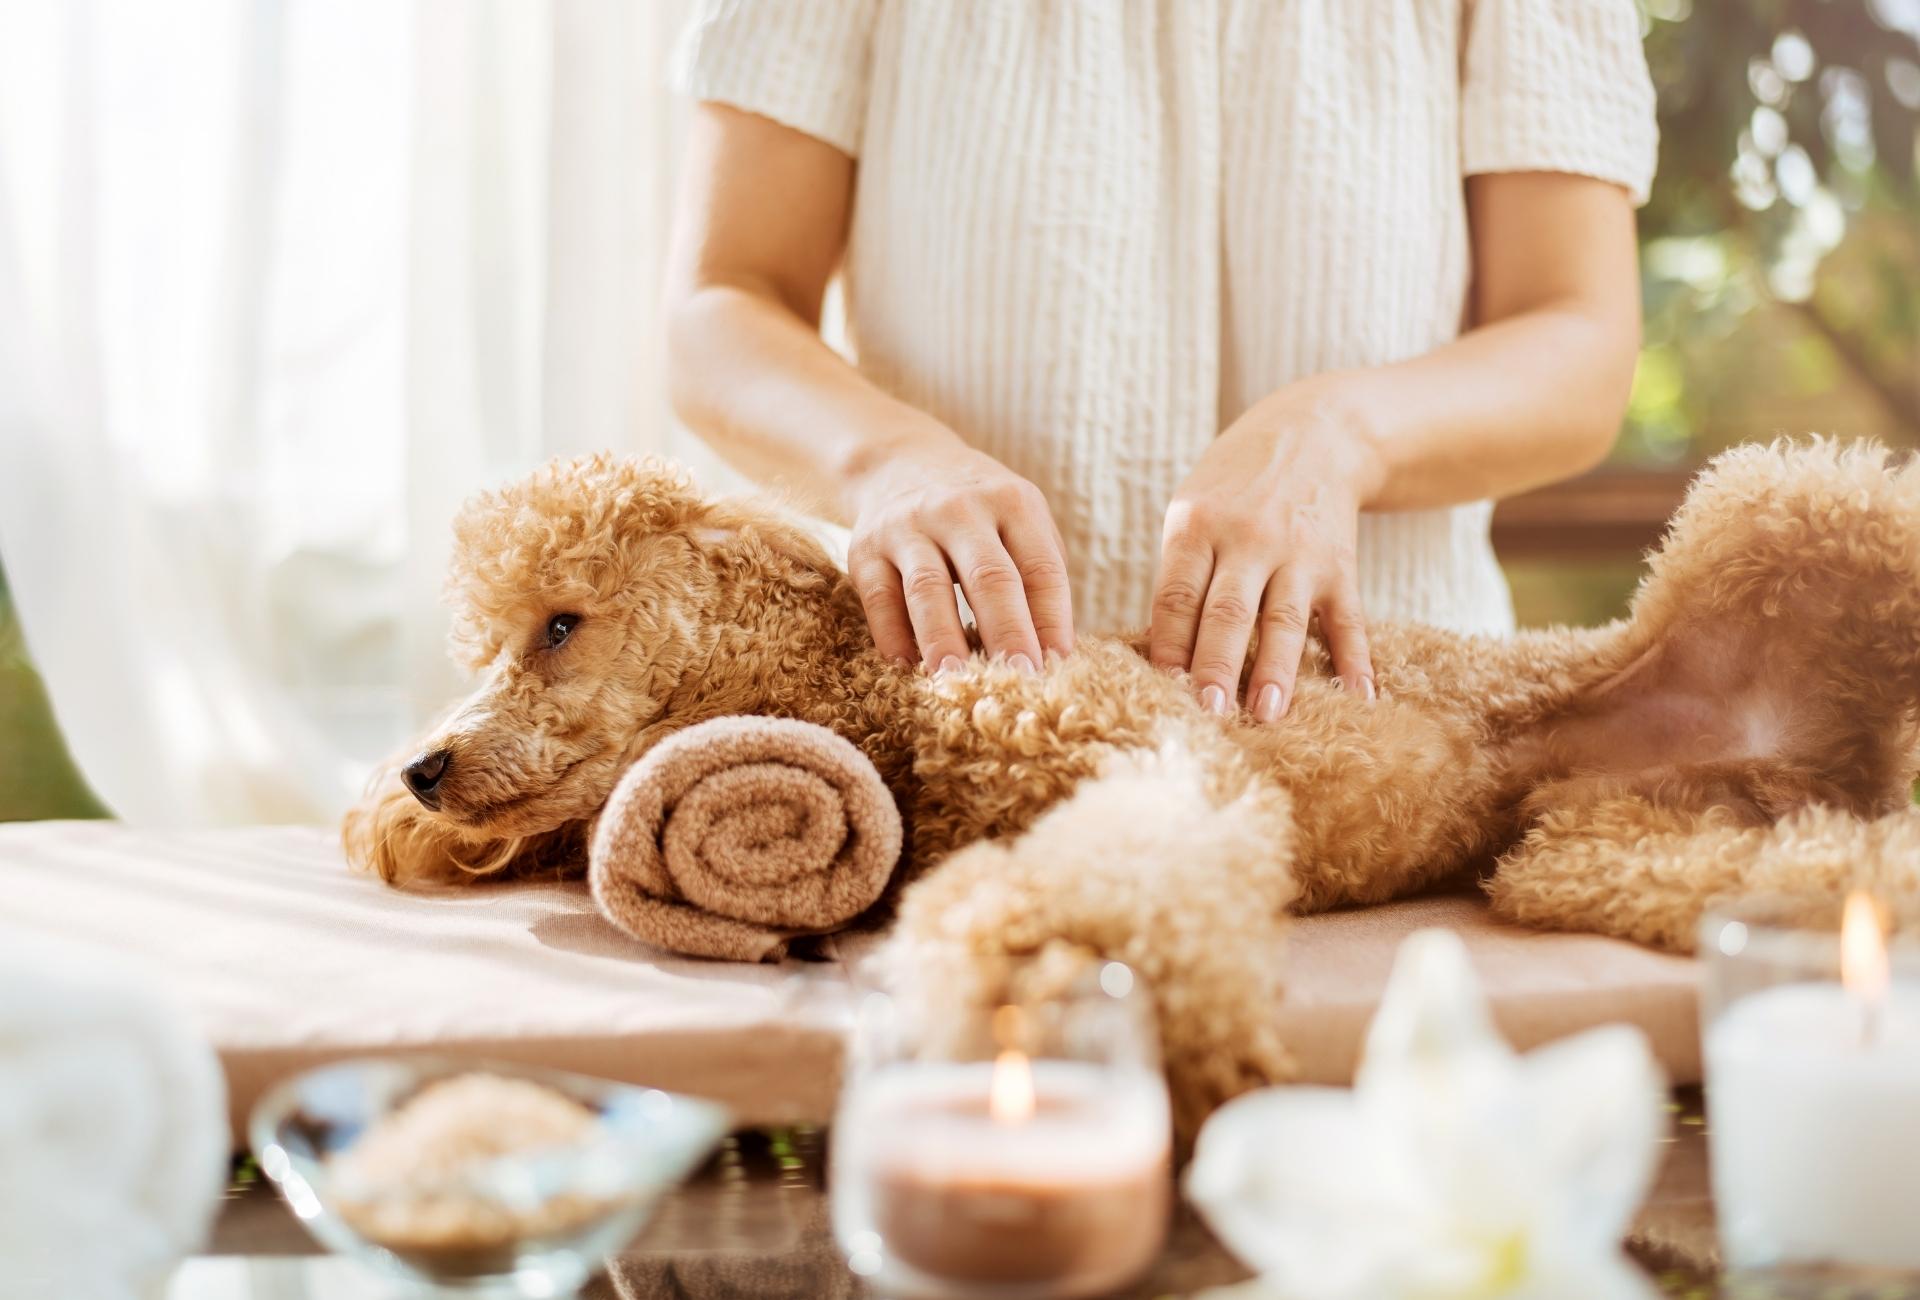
1699 895 1920 1273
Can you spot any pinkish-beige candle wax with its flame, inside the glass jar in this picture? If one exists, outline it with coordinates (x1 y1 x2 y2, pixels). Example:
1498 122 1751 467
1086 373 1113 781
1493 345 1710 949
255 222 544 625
833 1052 1171 1296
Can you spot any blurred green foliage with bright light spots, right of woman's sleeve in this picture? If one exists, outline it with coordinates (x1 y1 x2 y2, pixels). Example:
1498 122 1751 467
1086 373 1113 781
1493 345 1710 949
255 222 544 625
1615 0 1920 467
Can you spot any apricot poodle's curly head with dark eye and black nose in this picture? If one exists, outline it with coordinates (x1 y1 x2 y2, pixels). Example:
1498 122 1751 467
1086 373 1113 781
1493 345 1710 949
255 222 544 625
399 455 722 837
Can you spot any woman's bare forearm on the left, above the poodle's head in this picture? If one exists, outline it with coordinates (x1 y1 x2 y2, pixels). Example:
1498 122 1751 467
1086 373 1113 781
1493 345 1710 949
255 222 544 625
668 282 958 524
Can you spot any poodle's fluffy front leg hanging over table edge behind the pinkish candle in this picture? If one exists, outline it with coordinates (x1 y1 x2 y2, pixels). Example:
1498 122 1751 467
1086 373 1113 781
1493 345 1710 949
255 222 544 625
885 747 1294 1137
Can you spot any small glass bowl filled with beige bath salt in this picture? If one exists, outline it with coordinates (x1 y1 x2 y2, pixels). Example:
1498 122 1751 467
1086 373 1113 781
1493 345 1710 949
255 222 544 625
250 1058 728 1298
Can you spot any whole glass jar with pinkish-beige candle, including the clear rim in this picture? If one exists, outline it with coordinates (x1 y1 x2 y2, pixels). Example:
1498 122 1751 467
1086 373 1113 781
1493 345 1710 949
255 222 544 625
828 962 1173 1300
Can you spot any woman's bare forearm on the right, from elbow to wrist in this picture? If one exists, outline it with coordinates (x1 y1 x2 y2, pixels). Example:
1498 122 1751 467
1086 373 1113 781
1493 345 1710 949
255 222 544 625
1269 293 1640 511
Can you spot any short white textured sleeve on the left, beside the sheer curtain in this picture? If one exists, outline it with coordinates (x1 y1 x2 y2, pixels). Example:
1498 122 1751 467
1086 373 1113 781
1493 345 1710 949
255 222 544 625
674 0 876 156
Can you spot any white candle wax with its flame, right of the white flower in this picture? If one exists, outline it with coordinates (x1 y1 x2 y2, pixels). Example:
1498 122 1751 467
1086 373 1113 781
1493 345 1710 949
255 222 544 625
1707 895 1920 1269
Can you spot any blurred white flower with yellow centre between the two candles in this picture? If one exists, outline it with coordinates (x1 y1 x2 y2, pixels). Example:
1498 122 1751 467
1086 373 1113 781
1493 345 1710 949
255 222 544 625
1187 929 1667 1300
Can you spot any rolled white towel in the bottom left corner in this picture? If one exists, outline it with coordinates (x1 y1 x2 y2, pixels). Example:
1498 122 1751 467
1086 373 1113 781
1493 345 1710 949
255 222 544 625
0 927 228 1300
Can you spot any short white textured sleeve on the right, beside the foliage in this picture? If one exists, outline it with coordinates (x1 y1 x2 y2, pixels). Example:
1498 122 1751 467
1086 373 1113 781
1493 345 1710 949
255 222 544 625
1461 0 1659 207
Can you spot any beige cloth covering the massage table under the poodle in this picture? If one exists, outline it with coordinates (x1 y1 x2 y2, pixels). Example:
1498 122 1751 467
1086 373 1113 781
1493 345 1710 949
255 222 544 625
0 822 1699 1135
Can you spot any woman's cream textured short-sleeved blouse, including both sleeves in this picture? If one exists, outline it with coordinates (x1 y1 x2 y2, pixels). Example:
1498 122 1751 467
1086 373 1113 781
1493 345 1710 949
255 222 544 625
676 0 1655 632
